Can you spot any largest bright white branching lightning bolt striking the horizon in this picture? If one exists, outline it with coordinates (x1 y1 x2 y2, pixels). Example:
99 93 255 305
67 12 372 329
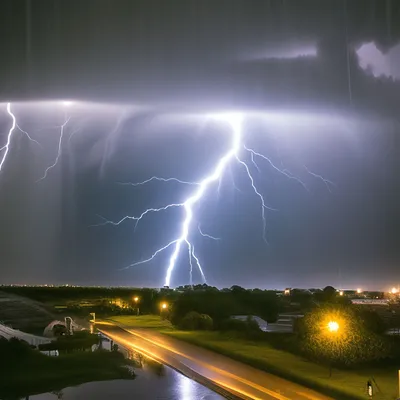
98 114 333 286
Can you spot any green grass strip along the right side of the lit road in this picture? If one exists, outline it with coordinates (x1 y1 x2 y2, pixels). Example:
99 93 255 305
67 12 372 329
113 315 398 400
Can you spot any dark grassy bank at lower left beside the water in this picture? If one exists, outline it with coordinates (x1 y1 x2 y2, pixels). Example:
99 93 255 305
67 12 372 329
0 349 134 399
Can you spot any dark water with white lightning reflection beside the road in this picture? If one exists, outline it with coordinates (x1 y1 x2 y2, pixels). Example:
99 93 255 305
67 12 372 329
29 366 223 400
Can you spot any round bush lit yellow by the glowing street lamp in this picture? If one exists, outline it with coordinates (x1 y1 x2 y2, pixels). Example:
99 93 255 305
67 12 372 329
296 306 390 366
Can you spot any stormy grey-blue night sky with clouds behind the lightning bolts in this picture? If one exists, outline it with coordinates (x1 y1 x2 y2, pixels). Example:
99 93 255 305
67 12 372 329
0 0 400 290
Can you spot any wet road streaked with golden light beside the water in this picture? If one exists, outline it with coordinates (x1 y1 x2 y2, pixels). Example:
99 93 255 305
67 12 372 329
96 323 332 400
